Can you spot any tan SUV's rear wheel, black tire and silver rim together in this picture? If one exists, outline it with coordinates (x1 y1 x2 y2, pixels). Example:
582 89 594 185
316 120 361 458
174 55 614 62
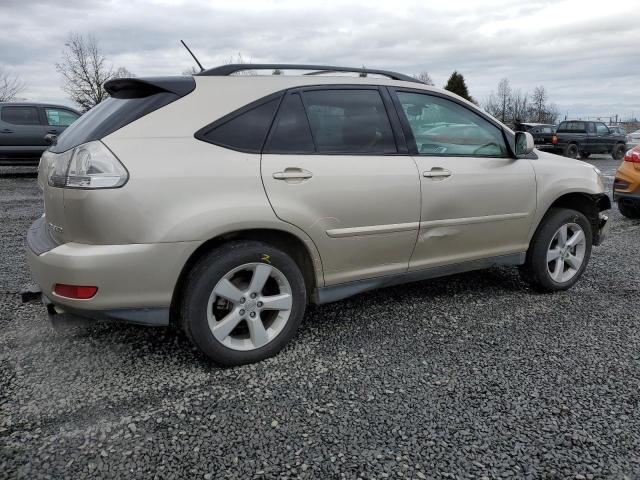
180 241 307 366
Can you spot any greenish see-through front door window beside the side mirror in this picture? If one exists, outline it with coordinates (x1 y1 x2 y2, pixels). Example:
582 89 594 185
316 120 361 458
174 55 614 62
398 92 508 157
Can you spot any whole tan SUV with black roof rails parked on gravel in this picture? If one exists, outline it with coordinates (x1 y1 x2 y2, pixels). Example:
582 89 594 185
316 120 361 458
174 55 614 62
27 64 610 365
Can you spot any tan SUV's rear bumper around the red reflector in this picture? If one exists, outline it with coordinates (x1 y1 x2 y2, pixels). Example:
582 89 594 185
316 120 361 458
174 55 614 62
27 217 200 325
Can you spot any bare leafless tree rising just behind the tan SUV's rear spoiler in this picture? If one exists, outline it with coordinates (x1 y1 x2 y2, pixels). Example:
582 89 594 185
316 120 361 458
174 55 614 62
56 34 133 111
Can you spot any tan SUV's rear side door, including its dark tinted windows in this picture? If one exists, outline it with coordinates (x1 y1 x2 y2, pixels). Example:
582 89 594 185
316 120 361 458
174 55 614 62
261 86 420 285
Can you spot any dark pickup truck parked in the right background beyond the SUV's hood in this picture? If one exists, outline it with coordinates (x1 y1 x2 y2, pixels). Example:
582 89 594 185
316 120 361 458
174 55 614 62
552 120 627 160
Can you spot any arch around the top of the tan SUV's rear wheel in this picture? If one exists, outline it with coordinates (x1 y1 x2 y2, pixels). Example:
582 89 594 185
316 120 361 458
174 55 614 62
170 228 324 323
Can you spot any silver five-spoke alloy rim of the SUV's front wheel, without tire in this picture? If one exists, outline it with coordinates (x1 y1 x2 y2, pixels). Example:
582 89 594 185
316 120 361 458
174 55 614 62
547 223 587 283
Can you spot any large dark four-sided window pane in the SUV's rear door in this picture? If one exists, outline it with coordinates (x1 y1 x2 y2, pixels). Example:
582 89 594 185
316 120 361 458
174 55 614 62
304 89 397 154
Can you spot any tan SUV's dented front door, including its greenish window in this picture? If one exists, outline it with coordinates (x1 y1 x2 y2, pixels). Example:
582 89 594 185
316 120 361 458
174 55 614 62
396 91 536 270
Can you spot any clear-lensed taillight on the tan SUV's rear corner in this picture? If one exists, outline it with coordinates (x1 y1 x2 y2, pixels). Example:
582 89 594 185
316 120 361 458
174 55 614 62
42 141 129 189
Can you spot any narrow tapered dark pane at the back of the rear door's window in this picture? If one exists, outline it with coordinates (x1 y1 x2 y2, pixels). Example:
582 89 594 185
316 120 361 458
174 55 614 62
265 93 315 153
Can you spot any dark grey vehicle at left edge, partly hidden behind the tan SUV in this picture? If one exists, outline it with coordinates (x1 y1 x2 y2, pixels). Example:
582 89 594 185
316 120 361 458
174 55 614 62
0 102 80 165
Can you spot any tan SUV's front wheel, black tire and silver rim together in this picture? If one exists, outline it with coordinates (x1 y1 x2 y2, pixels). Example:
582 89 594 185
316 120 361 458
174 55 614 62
520 208 593 292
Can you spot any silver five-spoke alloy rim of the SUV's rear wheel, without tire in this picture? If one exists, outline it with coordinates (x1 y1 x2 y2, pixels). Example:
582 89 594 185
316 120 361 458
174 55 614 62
207 263 293 351
